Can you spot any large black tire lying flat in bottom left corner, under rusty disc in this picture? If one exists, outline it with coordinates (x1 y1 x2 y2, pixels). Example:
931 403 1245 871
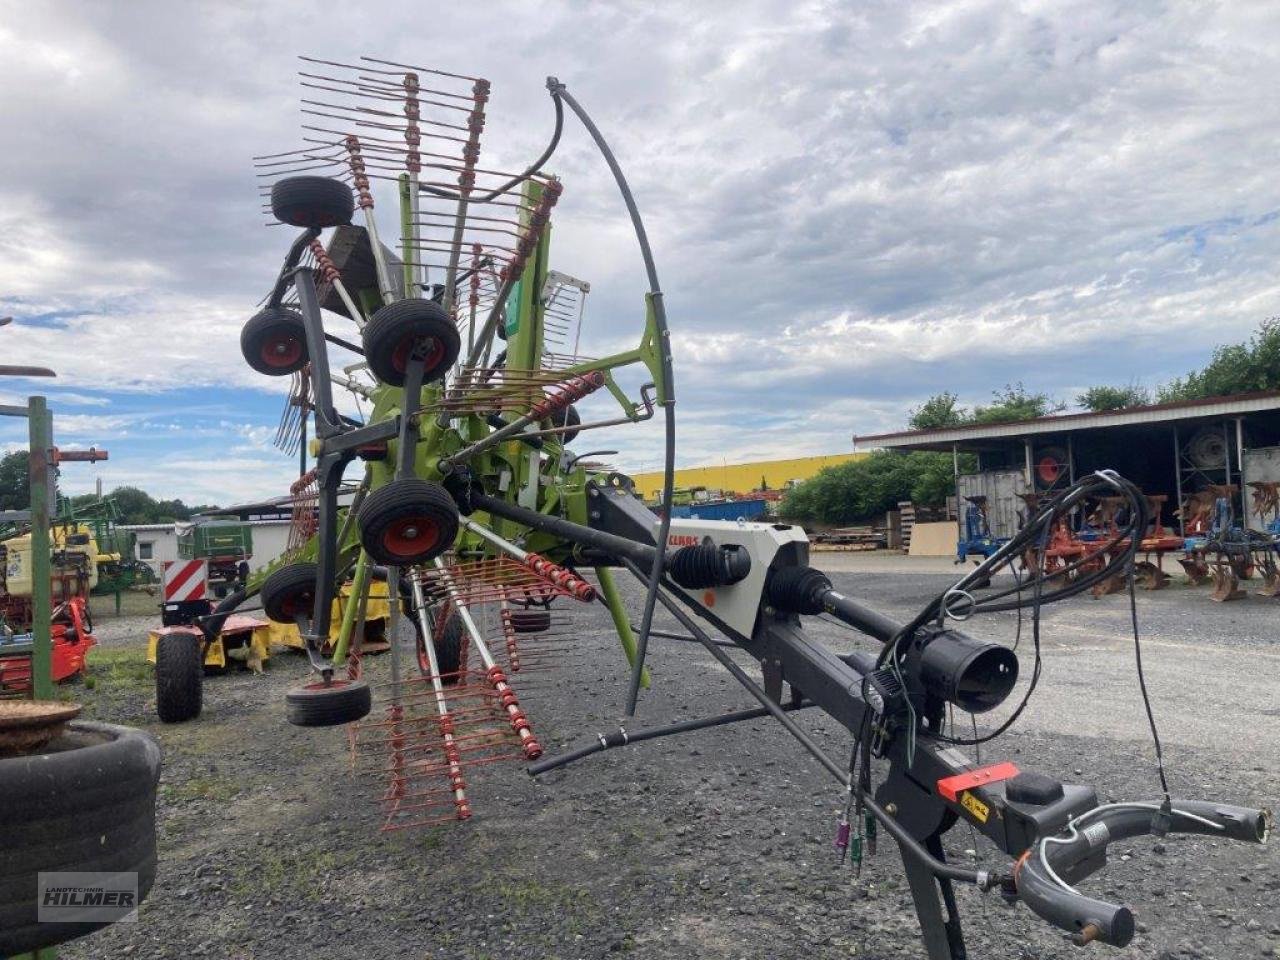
0 721 160 956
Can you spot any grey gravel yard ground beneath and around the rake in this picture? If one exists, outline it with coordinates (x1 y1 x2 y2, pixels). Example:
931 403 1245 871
60 554 1280 960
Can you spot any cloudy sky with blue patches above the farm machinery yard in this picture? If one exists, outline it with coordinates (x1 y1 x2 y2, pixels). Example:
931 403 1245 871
0 0 1280 503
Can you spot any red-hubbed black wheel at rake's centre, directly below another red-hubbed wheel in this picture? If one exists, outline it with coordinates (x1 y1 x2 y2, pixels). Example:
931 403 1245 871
356 478 458 566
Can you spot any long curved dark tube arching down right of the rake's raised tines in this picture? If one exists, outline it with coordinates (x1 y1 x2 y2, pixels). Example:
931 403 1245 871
547 77 676 717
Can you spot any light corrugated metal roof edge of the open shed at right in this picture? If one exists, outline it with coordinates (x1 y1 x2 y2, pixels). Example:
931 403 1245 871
854 390 1280 447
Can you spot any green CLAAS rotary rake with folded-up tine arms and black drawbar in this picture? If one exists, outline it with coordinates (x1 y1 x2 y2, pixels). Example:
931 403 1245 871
220 58 1270 960
